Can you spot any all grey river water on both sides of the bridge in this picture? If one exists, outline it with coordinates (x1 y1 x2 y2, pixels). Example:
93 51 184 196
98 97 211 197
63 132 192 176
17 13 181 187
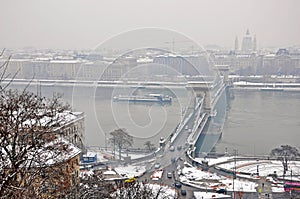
7 84 300 155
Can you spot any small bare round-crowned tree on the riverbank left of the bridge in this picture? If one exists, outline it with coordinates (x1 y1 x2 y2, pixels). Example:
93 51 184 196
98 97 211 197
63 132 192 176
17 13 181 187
109 129 133 160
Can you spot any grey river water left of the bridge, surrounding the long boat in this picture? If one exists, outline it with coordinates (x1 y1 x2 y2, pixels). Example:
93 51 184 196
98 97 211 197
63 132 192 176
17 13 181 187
11 84 190 148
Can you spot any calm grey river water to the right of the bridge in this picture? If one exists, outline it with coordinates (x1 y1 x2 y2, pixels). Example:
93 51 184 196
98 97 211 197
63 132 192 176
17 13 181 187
216 90 300 155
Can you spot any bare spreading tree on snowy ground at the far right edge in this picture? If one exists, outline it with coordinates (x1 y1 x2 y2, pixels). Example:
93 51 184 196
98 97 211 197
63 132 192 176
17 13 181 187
270 145 300 175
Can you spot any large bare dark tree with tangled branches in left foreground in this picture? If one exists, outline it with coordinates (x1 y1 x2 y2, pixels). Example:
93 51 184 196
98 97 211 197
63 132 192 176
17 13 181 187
0 52 78 198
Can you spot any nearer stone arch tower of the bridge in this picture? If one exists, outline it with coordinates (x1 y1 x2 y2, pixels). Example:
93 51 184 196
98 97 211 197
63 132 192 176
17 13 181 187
187 82 212 113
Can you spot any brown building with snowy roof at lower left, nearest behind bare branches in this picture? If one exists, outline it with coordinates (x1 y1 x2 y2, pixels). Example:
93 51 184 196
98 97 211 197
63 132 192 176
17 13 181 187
0 138 81 198
